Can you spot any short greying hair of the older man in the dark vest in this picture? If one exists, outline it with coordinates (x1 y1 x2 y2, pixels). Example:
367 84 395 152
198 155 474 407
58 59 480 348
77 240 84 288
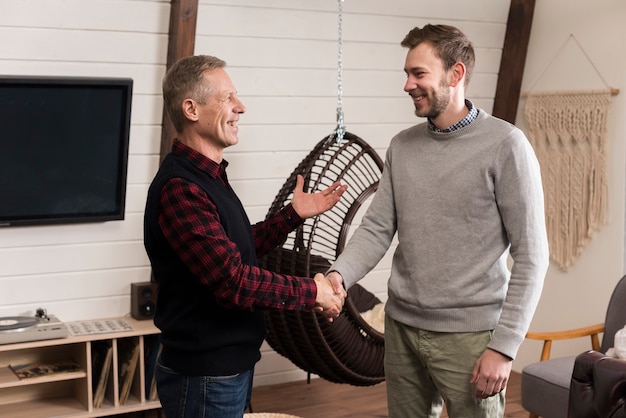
163 55 226 132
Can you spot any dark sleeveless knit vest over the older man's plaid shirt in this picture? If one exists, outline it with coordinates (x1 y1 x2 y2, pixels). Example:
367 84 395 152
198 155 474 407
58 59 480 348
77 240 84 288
144 153 265 376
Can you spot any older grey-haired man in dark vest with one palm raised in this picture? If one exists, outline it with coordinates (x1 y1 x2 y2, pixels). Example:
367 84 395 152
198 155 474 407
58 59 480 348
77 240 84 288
144 56 347 418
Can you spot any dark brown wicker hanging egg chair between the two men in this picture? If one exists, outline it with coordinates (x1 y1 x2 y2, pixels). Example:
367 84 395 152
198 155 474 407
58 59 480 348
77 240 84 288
260 132 384 386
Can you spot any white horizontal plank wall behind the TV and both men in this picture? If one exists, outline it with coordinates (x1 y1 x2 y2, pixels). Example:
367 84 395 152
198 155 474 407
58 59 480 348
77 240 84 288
0 0 509 385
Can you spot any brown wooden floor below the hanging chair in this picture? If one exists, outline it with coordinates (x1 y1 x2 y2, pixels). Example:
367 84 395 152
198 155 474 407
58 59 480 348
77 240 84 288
252 372 528 418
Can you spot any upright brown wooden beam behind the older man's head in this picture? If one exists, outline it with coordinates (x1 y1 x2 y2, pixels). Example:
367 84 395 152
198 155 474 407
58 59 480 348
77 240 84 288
160 0 198 161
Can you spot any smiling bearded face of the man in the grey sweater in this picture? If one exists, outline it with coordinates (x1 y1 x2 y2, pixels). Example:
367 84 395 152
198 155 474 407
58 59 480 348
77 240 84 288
404 42 451 120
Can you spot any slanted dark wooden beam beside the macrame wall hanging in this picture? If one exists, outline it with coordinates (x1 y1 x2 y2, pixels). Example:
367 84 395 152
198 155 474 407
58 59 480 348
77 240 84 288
492 0 535 123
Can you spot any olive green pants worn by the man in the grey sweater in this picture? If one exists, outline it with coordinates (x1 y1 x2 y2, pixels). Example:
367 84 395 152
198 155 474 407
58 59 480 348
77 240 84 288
385 315 505 418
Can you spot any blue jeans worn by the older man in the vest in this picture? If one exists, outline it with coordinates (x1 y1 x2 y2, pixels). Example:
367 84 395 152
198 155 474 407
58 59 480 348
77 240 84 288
156 359 254 418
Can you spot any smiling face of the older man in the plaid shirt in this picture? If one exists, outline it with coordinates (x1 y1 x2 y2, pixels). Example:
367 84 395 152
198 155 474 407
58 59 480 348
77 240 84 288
195 68 246 150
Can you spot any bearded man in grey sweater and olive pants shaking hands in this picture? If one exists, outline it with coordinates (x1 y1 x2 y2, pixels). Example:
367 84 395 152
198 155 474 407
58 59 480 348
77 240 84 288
328 25 548 418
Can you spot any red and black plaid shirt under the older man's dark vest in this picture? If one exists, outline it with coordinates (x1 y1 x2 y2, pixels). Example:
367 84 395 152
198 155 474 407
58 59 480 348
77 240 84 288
159 141 317 310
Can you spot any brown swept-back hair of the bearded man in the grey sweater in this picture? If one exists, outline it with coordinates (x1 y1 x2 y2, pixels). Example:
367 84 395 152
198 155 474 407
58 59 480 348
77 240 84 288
400 24 476 86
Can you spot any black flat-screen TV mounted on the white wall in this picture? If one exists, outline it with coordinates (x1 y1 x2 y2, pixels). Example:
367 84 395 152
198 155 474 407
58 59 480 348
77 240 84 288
0 76 133 226
